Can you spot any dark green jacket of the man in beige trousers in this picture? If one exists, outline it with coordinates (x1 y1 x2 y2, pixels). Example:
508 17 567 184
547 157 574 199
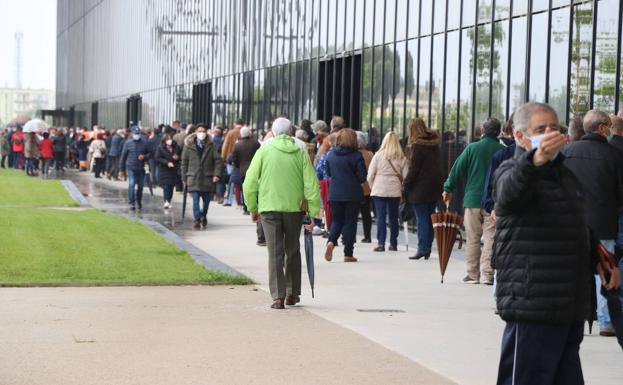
443 136 504 208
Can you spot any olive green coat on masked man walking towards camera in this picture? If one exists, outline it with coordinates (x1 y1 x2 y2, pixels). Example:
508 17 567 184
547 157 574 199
182 134 223 192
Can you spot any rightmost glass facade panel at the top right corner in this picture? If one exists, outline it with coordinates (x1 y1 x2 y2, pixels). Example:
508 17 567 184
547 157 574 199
593 0 619 112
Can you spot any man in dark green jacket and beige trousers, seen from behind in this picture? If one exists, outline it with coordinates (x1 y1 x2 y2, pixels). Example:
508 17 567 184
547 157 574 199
443 118 504 285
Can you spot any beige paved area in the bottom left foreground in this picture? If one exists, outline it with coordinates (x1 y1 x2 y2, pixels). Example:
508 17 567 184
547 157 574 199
0 286 450 385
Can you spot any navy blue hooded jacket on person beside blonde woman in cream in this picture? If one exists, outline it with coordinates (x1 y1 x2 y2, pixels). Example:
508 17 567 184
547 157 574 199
325 146 368 202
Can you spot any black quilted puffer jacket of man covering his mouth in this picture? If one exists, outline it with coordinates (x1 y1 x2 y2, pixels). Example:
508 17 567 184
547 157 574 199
493 147 595 323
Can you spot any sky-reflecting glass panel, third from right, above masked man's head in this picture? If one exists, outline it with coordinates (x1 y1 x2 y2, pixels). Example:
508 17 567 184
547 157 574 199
549 8 569 121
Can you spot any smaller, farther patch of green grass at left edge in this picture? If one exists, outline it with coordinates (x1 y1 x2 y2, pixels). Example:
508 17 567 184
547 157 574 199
0 169 77 207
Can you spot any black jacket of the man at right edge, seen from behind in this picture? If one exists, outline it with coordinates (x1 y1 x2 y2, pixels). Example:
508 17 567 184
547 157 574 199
562 134 623 239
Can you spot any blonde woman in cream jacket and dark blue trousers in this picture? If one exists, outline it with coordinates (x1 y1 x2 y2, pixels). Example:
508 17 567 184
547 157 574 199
368 131 408 251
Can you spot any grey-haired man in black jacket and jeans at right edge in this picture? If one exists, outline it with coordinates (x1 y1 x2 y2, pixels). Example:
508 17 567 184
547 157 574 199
563 110 623 336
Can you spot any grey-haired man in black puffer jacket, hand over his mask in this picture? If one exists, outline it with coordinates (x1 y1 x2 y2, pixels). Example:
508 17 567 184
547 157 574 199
493 103 620 385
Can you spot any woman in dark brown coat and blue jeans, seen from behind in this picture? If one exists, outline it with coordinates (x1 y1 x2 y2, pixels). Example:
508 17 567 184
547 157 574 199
404 118 443 259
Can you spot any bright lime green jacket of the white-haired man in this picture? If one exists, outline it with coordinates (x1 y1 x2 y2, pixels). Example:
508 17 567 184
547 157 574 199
242 135 320 216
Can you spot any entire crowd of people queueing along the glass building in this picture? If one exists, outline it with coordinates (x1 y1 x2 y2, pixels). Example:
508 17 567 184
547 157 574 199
8 103 623 384
